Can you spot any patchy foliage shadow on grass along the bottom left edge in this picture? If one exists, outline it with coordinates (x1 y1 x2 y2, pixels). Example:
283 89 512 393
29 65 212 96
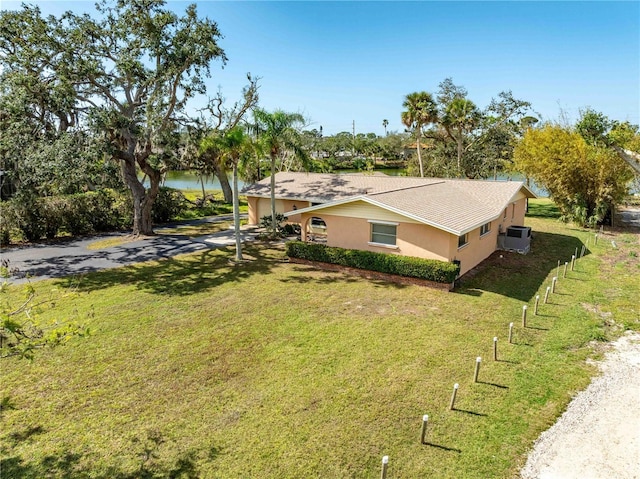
0 433 219 479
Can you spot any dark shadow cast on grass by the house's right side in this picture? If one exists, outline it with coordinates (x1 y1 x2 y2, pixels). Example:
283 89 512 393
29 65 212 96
453 231 588 303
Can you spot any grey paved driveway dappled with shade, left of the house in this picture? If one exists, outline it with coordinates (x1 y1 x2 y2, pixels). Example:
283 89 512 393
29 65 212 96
0 216 257 284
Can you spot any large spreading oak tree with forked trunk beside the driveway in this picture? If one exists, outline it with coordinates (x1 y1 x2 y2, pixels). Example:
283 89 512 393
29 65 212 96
0 0 226 234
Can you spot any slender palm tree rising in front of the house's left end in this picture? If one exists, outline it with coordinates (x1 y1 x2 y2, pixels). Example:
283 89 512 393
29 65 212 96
254 109 310 235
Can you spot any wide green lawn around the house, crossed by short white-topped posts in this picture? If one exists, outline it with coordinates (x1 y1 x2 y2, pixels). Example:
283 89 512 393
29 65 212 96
0 200 640 479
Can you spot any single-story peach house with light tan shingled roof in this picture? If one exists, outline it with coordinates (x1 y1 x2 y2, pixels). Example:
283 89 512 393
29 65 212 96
244 172 535 275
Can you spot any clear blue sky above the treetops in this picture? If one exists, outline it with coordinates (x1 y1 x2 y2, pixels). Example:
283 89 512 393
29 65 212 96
1 0 640 135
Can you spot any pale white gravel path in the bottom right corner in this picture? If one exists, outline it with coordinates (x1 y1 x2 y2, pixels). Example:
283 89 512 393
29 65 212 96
521 333 640 479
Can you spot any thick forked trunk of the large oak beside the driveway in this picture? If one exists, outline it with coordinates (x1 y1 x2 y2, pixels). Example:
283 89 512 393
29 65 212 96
122 160 161 236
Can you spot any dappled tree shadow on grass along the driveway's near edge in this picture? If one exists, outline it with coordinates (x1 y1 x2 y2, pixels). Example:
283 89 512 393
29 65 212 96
58 245 281 296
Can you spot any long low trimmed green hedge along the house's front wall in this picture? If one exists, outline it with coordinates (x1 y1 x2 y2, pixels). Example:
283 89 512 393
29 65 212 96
285 241 460 283
